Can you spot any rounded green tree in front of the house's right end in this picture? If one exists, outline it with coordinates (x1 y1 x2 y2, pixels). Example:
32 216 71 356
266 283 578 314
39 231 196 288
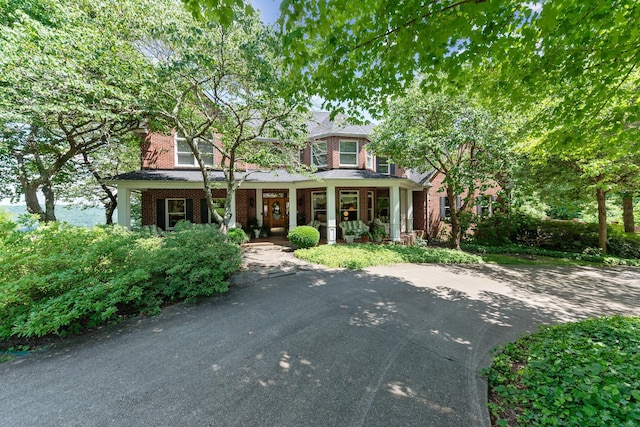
370 88 511 249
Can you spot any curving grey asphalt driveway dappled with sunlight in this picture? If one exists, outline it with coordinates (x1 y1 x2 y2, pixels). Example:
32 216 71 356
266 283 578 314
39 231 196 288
0 247 640 426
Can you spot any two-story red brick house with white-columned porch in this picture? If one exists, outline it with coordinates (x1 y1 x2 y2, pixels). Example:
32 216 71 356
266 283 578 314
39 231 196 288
114 112 496 244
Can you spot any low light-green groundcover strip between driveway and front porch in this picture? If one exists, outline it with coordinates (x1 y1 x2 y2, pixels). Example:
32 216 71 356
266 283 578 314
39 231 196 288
295 244 483 269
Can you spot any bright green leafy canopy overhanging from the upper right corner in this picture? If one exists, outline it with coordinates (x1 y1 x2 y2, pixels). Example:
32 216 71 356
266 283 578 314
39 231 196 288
276 0 640 151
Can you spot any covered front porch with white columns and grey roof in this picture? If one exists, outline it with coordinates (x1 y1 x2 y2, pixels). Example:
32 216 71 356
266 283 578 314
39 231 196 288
116 170 426 244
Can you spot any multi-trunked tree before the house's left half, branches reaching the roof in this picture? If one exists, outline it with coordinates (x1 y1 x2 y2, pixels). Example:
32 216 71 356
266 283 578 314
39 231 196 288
145 4 308 232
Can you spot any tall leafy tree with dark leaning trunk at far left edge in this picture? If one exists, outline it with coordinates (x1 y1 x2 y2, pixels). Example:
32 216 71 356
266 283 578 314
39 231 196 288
0 0 155 221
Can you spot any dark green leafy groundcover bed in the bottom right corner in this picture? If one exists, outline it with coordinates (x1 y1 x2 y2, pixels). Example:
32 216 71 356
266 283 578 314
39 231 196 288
485 316 640 426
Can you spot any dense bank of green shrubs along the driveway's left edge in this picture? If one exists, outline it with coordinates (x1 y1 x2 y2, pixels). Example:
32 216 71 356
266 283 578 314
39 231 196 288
0 223 241 339
